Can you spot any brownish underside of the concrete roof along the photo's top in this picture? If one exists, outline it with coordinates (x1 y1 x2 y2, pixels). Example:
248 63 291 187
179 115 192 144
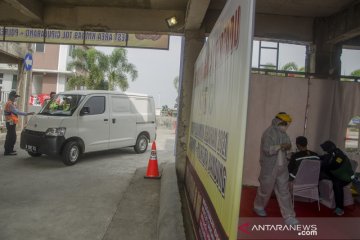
0 0 359 41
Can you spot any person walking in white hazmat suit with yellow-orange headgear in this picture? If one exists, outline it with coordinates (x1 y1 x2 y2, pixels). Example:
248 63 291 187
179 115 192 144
254 112 299 225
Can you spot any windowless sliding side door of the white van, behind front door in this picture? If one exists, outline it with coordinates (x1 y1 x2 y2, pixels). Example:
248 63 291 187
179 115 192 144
109 95 137 148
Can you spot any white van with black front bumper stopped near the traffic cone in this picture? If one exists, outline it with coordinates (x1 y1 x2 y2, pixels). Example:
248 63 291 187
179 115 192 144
20 91 156 165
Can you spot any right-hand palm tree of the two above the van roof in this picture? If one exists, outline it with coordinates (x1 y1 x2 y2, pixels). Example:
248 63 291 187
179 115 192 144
107 48 138 91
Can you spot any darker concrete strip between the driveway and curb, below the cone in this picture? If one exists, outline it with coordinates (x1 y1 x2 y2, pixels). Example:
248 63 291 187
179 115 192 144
103 168 161 240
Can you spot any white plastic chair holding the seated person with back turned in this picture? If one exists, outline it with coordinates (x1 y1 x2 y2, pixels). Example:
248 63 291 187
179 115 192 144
292 159 320 211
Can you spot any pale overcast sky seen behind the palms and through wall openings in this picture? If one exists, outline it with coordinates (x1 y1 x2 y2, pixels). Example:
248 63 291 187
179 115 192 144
97 36 360 108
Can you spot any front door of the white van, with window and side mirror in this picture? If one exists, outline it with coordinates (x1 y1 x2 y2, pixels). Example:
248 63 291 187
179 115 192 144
79 95 110 152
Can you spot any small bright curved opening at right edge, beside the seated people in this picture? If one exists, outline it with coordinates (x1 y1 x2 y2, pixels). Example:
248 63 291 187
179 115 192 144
345 116 360 152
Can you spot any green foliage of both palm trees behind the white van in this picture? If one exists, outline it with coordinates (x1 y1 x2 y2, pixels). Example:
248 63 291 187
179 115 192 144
67 48 138 91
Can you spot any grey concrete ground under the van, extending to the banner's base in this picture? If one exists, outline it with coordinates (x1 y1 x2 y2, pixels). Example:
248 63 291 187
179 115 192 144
0 129 185 240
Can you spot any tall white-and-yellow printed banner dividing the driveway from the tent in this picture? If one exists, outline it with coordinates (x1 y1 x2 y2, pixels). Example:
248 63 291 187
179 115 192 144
187 0 255 239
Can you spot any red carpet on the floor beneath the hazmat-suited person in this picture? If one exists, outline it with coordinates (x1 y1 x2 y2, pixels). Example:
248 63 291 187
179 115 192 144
240 186 360 217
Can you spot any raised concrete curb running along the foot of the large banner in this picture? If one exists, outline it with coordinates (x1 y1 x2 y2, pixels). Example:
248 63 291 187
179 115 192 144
157 163 186 240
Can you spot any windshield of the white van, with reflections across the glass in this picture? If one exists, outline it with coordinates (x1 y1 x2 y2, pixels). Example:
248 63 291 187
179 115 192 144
39 94 84 116
